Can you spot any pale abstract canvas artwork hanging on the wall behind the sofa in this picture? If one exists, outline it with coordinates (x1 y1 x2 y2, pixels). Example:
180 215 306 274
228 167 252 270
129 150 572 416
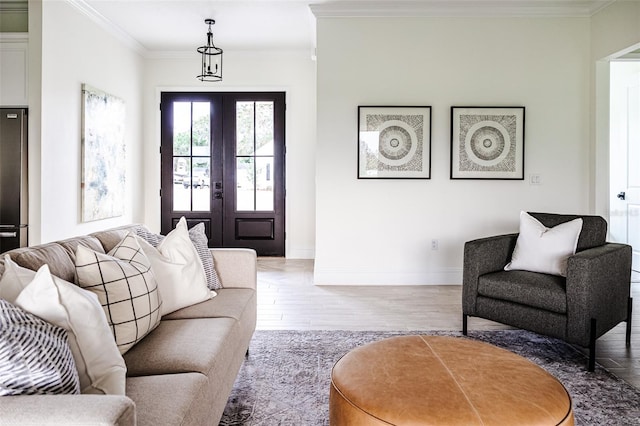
81 84 126 222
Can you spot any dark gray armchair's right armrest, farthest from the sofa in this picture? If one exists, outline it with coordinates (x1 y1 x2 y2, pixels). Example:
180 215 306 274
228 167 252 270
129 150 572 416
567 243 632 346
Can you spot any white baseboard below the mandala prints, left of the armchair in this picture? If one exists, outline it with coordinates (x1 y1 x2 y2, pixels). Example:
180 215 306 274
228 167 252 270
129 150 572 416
314 268 462 286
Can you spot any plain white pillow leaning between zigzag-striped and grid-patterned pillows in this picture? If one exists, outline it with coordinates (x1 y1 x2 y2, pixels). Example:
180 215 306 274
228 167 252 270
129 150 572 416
5 260 127 395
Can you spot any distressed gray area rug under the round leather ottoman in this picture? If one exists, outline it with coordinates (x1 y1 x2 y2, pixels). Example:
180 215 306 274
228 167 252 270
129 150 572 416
220 330 640 426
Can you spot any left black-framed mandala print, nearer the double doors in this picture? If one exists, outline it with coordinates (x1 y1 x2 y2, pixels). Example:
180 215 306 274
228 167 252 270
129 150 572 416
358 106 431 179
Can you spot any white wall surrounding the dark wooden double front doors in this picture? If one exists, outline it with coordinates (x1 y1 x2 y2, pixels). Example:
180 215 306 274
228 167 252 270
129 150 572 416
144 50 316 258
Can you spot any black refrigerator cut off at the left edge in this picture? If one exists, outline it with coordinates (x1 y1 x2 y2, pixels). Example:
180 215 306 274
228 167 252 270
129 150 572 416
0 108 28 253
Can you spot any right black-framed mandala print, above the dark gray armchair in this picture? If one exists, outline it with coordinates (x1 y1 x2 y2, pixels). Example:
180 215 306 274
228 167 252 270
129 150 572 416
451 106 524 180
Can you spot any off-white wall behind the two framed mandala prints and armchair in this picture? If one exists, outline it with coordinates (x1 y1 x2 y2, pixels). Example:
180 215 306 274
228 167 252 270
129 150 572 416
315 17 591 284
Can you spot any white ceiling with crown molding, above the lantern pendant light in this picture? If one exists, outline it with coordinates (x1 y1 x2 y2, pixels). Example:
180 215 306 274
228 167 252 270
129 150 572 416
7 0 613 56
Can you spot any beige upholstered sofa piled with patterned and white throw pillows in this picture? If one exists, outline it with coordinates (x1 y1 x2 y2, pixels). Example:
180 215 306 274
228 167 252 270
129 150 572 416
0 225 256 426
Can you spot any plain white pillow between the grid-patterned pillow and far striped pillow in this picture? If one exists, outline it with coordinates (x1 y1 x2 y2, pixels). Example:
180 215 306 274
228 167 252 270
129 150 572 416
137 237 216 315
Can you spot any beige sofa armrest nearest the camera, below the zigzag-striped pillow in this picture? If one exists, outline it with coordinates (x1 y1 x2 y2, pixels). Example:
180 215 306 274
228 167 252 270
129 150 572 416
0 394 136 426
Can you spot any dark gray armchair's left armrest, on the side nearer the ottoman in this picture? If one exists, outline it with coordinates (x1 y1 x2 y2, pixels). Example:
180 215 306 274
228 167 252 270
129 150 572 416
462 234 518 315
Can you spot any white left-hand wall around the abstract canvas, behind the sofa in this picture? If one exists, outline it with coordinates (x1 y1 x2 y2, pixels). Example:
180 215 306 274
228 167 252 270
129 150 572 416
36 1 143 244
